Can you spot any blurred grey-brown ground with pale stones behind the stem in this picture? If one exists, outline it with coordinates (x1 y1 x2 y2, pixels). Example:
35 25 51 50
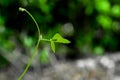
0 53 120 80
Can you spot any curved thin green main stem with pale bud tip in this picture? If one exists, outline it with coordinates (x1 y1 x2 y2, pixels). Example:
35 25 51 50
18 7 41 80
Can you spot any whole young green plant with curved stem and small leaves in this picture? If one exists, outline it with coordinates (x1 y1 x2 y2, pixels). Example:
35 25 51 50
18 7 70 80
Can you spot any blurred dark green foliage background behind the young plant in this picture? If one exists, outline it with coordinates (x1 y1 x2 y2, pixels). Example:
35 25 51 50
0 0 120 66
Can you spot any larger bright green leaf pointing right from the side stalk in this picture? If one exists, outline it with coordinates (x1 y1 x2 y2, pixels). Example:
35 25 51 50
52 33 70 44
